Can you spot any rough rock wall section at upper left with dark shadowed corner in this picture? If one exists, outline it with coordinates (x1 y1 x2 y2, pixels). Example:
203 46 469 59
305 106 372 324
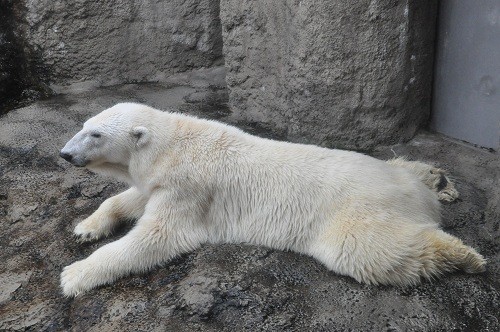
0 0 223 114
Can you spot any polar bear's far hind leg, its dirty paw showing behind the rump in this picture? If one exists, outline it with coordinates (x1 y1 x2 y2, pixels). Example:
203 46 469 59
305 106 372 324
387 157 458 202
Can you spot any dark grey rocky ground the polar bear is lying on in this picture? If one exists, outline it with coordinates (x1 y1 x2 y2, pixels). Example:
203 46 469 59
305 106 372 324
0 76 500 332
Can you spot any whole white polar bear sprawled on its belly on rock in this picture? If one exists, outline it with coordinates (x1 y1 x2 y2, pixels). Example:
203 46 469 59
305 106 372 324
60 103 485 296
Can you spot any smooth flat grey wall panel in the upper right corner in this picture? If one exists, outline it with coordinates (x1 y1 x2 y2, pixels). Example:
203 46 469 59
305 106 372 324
431 0 500 150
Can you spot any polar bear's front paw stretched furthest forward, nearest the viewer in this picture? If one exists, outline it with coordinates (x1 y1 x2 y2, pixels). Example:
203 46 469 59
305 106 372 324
61 260 93 296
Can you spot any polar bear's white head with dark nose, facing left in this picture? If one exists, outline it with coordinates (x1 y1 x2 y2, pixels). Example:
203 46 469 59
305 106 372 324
60 103 155 169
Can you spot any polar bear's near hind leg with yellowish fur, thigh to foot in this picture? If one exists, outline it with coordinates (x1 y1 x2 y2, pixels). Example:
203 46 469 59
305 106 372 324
309 213 486 286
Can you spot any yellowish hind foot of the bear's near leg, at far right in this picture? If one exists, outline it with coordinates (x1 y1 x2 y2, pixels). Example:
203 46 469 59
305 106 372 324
421 230 486 279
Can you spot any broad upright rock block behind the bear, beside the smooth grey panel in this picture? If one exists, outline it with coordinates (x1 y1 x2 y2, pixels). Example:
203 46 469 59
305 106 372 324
221 0 436 149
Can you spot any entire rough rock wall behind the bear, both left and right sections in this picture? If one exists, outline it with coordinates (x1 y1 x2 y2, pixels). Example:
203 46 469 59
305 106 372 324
0 0 436 150
